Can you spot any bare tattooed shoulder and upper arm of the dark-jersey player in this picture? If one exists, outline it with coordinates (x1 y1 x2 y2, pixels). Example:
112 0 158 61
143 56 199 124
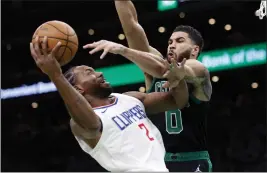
185 59 212 101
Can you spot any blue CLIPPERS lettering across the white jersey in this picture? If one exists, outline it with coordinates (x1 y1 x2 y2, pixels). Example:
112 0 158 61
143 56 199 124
112 105 147 130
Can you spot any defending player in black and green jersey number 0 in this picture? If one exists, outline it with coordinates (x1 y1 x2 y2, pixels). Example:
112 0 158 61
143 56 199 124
115 1 212 172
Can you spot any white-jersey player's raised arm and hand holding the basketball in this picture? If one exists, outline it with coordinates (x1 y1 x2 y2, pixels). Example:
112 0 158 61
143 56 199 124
30 36 101 138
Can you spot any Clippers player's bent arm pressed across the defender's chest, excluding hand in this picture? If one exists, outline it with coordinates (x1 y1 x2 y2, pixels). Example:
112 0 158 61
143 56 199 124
124 80 188 114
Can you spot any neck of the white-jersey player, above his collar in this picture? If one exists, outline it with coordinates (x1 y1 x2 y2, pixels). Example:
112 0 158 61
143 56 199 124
84 95 114 108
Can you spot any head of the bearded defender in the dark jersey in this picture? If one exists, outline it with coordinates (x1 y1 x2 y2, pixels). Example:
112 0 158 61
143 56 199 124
167 25 204 62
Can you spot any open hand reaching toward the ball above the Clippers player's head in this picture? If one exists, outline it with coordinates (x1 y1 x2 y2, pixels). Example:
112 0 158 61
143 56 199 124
83 40 125 59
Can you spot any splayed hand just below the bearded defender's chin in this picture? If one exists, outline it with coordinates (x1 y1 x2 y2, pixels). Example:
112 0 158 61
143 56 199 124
163 58 186 89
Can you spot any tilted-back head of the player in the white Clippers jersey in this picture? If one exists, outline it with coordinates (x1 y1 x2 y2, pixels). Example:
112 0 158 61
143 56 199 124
64 65 112 98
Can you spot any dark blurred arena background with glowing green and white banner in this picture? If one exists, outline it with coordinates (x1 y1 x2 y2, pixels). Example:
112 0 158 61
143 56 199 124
1 0 267 172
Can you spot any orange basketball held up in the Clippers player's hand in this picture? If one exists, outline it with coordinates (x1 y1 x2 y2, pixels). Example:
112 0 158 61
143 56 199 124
32 20 78 66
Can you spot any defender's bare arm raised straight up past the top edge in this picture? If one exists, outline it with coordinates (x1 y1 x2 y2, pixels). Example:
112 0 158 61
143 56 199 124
115 0 163 88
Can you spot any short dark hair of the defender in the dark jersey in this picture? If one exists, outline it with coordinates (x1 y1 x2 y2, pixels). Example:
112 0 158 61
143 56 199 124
173 25 204 55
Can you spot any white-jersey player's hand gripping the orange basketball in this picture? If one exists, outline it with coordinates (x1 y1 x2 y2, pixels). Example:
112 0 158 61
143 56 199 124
30 36 62 79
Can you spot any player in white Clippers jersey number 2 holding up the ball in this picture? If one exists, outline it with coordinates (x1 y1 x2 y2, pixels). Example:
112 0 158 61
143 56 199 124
30 36 188 172
